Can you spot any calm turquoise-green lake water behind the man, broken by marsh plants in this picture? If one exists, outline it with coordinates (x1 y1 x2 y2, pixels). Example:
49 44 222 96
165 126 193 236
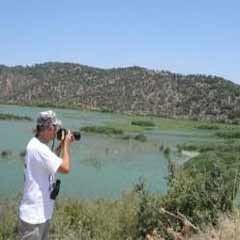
0 105 218 198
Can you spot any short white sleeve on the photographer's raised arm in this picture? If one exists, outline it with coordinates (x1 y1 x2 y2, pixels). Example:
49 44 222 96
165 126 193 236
38 146 63 175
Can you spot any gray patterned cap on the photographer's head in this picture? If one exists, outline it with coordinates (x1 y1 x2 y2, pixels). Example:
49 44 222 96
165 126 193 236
37 110 62 127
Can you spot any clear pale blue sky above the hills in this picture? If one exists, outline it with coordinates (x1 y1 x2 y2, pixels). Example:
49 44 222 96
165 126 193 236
0 0 240 84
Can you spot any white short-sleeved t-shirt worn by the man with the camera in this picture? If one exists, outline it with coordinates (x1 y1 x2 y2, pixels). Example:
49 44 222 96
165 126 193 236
19 137 62 224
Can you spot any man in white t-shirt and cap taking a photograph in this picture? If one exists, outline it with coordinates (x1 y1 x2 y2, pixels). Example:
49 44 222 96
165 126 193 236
19 110 74 240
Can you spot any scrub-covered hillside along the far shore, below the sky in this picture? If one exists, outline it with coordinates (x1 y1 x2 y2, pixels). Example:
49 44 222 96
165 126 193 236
0 62 240 122
